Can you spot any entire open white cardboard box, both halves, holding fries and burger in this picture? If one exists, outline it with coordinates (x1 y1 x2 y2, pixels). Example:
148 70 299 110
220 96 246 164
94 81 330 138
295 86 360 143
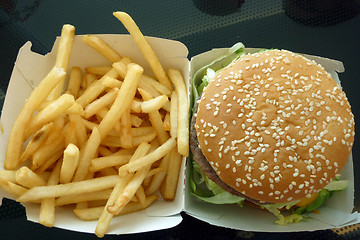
0 34 360 234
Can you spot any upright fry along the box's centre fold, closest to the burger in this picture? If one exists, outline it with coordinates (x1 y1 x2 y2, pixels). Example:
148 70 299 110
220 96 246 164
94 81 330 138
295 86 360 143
168 69 189 156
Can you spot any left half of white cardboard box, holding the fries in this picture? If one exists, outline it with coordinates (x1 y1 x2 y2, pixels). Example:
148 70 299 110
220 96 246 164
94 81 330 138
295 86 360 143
0 34 189 234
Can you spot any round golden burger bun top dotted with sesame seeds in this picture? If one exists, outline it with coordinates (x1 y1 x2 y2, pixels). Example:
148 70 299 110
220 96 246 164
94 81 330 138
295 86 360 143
195 50 354 203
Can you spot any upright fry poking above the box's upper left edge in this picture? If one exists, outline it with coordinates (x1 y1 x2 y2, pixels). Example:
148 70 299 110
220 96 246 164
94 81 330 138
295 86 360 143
48 24 75 100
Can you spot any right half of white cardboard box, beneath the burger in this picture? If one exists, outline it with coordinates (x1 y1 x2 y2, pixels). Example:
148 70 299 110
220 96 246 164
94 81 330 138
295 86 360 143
185 48 360 232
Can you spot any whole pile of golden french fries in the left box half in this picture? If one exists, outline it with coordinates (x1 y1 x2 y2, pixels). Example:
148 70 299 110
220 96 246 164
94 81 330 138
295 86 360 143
0 12 189 237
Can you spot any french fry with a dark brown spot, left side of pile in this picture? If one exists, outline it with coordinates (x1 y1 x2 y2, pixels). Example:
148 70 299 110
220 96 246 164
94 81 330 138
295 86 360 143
20 122 54 163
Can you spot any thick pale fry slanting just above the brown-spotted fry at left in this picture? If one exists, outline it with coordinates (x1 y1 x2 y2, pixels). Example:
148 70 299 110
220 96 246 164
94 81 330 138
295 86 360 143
25 93 75 138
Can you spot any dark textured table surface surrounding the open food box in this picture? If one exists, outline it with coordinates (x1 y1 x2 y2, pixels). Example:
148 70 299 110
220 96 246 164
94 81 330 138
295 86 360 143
0 0 360 240
